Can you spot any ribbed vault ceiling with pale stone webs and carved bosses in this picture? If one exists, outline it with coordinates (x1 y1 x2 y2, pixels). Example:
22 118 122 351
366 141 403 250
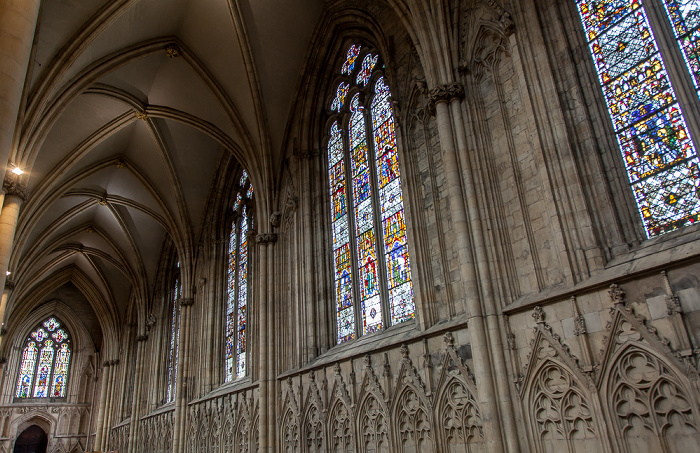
10 0 322 350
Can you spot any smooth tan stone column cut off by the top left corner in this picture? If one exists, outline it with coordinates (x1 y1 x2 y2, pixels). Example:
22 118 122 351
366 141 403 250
0 0 41 171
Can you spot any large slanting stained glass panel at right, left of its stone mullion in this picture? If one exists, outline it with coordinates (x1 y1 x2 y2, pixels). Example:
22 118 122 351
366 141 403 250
577 0 700 237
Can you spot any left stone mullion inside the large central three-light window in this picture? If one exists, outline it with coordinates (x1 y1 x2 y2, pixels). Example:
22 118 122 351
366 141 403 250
336 123 364 338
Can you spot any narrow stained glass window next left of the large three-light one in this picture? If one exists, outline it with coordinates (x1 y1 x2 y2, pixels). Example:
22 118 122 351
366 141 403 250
224 170 253 382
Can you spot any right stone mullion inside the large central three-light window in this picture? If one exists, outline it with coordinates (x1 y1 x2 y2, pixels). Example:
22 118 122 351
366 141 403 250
364 100 391 329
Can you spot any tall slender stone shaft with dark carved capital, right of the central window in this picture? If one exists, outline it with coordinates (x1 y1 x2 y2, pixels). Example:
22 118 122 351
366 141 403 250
430 83 503 453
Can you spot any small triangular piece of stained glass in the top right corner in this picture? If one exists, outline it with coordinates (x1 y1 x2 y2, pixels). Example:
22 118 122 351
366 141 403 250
664 0 700 90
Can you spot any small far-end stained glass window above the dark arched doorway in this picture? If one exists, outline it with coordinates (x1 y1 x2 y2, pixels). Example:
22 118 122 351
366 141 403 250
15 317 71 398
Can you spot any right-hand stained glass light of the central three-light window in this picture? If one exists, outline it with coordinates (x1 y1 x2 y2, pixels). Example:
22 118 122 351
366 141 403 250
372 77 416 324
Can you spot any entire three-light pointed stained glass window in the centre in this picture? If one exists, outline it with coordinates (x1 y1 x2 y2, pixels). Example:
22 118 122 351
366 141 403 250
328 44 415 343
